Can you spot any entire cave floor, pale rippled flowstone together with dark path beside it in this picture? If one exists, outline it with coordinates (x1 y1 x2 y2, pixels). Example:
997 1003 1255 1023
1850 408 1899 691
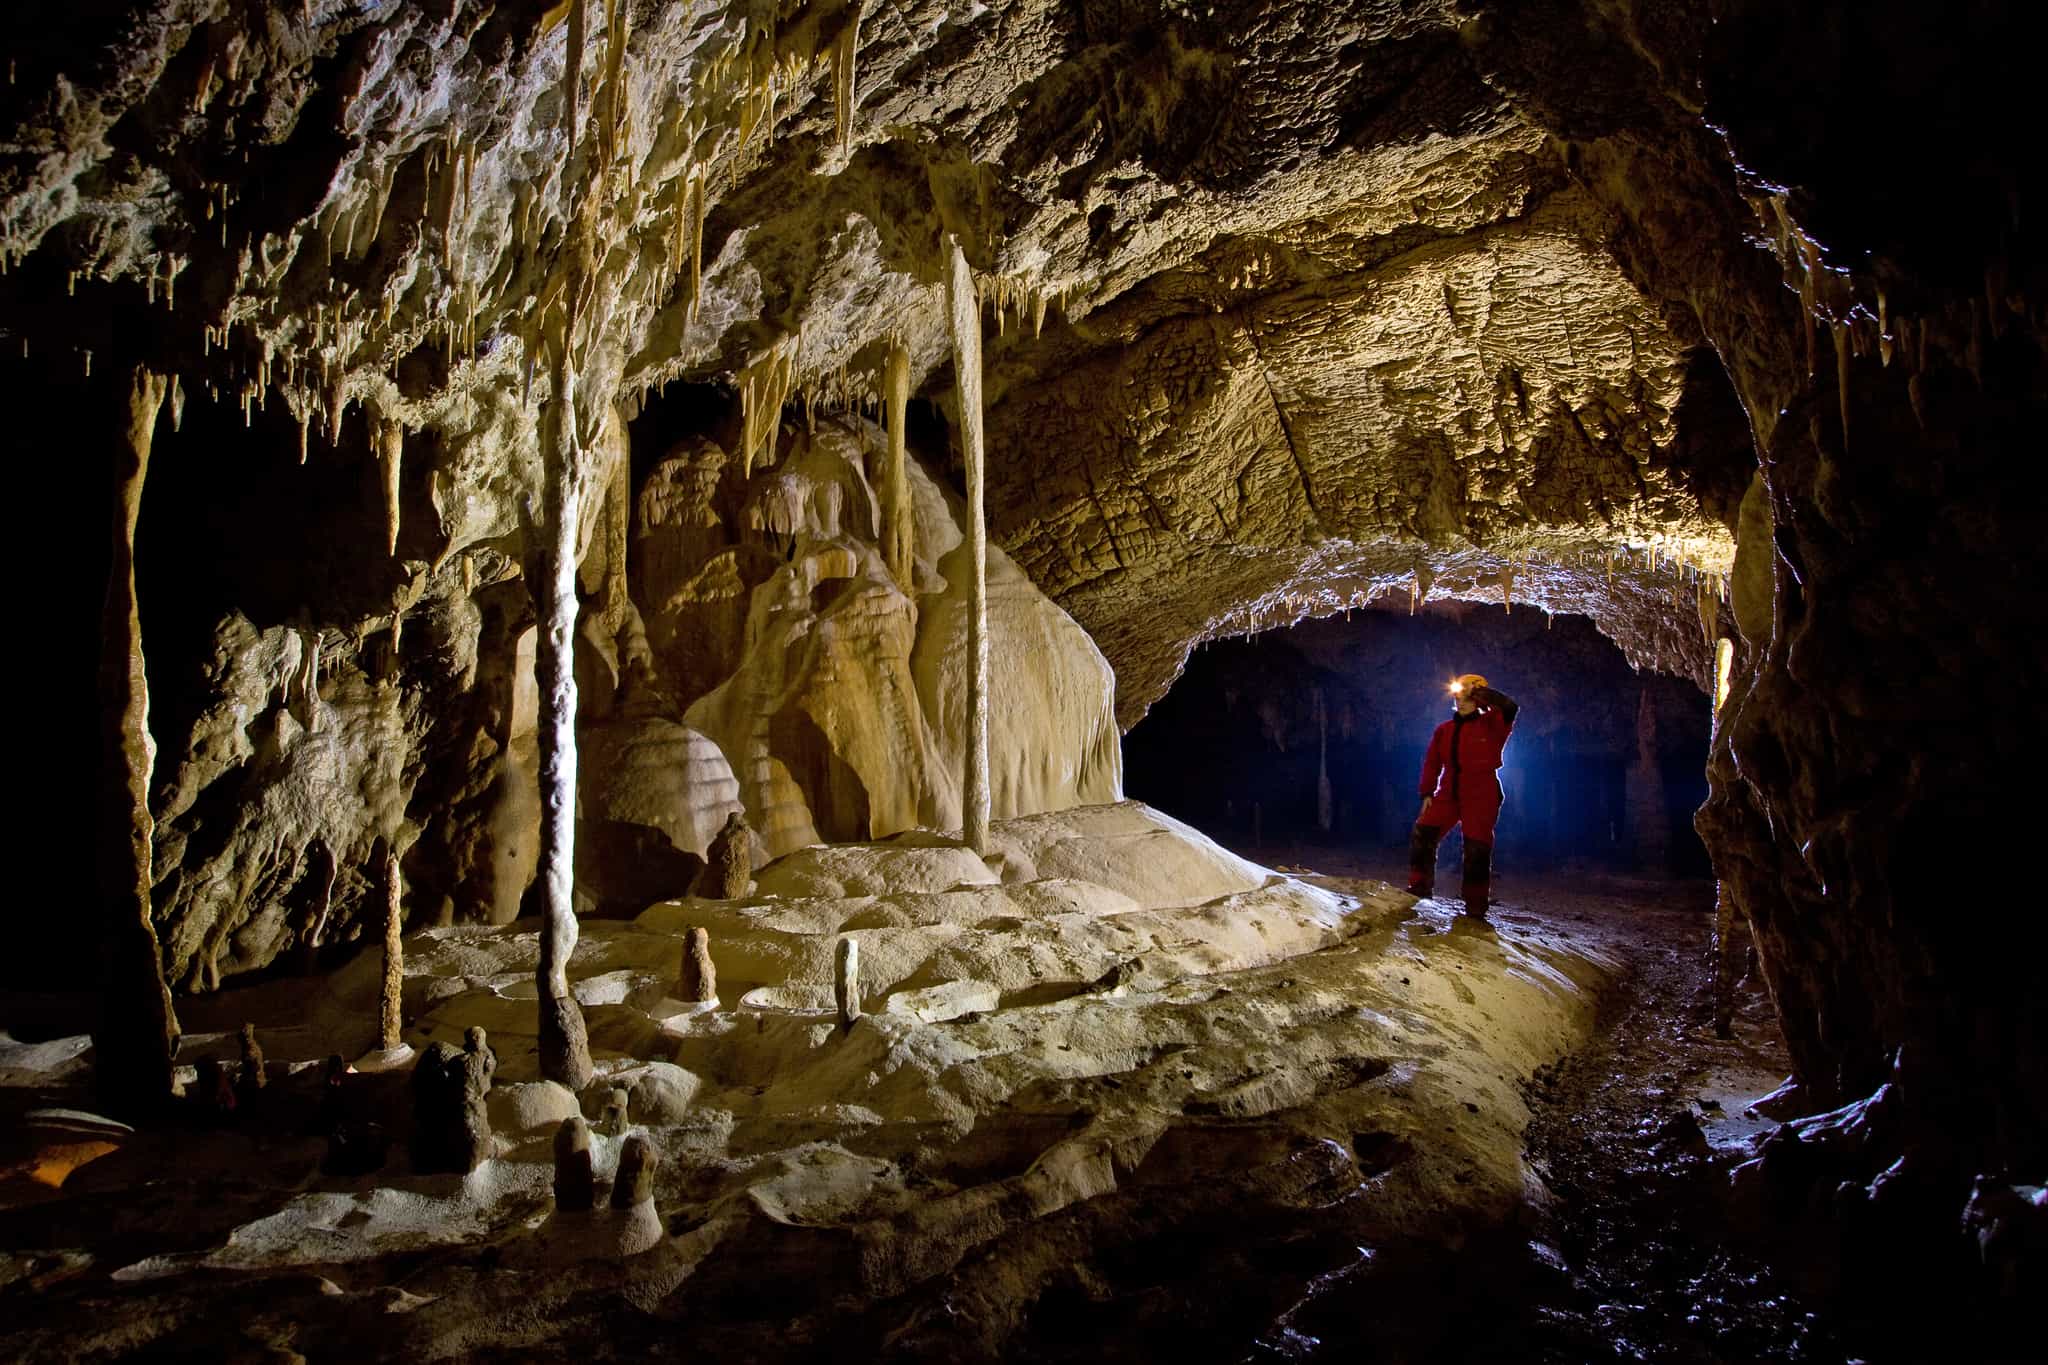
0 818 1839 1361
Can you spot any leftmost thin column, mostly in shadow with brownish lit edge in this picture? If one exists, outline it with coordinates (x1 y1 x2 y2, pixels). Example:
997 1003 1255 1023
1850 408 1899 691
92 366 178 1107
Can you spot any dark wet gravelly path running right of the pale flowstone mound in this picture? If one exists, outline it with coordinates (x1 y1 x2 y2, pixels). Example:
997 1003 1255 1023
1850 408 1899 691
1239 845 1851 1365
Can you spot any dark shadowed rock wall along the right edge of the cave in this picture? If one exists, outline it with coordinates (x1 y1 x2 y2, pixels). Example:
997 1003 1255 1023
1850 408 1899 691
1473 4 2048 1185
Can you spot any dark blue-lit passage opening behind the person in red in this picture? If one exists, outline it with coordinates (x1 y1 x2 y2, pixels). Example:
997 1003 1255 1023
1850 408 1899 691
1124 602 1712 878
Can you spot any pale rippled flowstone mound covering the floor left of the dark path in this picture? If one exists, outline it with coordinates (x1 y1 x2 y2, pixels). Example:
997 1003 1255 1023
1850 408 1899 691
0 802 1610 1359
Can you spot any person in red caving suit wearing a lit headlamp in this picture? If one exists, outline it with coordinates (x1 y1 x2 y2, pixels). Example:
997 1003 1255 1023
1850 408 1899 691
1409 673 1522 919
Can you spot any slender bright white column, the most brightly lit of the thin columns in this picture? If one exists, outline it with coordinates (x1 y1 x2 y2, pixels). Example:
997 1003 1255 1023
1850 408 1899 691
532 344 592 1091
